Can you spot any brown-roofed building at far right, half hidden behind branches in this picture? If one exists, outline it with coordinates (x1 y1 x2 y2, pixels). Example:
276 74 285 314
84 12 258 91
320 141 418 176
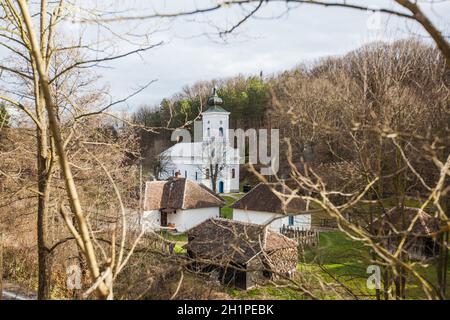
369 207 439 260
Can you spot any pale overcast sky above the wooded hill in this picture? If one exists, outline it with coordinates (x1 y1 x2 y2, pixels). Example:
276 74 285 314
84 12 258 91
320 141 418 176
5 0 450 110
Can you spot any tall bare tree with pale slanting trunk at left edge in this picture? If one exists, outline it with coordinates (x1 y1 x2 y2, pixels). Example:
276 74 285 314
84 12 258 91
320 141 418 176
0 1 159 298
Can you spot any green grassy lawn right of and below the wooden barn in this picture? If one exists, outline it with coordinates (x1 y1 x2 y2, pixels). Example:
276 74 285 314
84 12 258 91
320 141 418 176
230 231 450 300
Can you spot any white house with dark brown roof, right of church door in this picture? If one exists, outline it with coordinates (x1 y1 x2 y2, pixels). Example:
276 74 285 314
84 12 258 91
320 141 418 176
231 183 311 231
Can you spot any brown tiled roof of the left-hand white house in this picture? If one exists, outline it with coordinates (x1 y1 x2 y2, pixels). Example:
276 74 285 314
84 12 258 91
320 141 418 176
144 178 225 211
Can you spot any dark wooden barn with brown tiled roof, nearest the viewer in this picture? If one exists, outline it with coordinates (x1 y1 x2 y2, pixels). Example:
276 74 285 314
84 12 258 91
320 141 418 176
184 218 298 290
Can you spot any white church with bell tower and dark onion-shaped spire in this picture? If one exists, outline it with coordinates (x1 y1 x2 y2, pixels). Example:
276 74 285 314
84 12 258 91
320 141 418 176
158 88 240 193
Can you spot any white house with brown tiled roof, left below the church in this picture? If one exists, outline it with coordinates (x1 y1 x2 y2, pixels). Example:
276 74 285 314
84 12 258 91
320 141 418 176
142 177 225 232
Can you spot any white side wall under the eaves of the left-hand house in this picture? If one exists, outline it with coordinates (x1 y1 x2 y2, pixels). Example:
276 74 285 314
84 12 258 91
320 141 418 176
167 207 220 232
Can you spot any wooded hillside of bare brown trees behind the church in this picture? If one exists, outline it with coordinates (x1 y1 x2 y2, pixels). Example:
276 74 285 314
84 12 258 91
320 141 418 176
134 39 449 192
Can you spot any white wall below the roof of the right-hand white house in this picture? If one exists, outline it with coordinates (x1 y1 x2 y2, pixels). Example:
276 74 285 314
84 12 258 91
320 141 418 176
233 209 311 231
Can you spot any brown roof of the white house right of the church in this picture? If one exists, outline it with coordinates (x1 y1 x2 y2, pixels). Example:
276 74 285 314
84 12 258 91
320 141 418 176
231 182 306 214
